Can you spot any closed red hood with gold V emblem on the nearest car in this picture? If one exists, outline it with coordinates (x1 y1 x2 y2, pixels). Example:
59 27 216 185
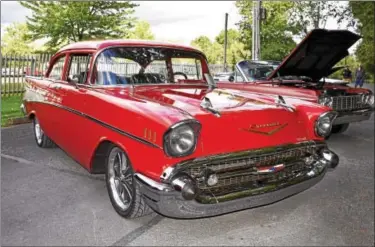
128 87 318 154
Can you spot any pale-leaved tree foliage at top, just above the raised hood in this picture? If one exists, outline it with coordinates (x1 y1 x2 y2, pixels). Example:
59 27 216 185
288 1 351 36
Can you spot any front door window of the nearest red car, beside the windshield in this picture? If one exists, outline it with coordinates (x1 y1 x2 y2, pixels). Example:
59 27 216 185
68 54 91 84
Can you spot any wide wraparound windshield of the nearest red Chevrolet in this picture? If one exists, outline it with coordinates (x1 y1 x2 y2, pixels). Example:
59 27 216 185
93 47 205 85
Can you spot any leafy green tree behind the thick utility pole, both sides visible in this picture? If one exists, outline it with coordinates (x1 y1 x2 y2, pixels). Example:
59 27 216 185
236 0 300 60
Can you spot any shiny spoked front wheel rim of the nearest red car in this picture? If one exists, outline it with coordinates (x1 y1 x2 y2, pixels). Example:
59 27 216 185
107 148 134 210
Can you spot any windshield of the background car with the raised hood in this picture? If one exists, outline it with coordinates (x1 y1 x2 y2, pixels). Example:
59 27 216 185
238 61 274 81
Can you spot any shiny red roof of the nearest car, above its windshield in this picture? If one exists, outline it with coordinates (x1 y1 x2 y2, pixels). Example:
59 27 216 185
58 39 202 53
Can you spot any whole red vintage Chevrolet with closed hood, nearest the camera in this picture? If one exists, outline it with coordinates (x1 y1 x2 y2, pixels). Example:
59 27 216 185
21 40 339 218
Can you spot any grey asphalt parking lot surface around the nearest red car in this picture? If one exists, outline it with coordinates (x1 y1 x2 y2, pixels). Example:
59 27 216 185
1 115 374 246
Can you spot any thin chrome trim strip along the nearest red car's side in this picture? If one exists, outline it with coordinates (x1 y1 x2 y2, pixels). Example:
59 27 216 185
29 100 162 149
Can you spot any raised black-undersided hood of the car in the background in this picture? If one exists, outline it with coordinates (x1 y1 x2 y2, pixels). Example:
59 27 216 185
267 29 361 81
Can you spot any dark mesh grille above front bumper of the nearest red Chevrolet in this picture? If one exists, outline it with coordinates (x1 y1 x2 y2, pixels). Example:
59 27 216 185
176 143 325 201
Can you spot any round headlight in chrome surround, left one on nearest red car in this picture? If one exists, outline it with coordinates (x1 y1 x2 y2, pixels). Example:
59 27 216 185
164 120 201 157
